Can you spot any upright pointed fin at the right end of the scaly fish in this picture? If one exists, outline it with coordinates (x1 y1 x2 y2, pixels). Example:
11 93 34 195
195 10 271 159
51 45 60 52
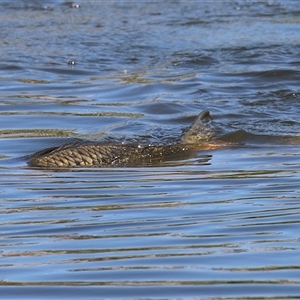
180 110 213 144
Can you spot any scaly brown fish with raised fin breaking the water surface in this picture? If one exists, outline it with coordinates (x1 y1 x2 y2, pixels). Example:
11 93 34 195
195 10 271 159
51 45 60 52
28 111 224 168
